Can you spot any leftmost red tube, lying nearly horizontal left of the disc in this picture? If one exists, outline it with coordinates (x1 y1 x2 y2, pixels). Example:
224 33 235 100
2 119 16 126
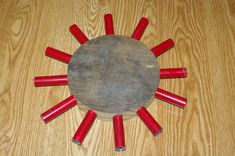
34 75 68 87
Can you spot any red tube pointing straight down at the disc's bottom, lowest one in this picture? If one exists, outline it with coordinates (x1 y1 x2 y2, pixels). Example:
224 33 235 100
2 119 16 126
113 114 126 151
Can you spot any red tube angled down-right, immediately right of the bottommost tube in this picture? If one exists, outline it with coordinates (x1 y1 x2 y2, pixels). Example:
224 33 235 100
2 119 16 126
136 106 162 136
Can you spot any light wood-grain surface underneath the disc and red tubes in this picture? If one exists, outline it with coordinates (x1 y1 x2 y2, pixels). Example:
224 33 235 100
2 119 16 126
0 0 235 156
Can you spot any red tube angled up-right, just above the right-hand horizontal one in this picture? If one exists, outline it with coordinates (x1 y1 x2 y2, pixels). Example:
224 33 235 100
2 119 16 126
151 39 174 57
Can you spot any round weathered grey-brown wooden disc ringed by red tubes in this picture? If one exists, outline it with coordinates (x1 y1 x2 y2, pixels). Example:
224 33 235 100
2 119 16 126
68 35 159 119
